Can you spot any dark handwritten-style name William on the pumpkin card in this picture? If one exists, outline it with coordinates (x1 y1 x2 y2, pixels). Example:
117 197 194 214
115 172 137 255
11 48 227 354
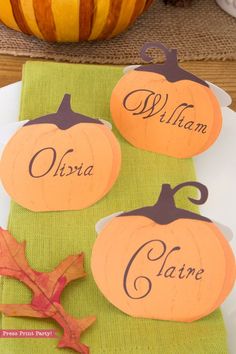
123 89 207 134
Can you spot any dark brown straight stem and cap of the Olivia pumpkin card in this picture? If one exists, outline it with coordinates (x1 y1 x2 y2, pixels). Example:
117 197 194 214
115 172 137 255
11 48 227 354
24 94 104 130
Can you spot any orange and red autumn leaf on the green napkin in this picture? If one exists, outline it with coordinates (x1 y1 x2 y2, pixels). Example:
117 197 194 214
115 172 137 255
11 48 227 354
0 228 95 354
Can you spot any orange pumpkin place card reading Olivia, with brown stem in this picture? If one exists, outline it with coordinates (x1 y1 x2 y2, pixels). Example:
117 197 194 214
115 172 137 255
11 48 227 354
0 95 121 211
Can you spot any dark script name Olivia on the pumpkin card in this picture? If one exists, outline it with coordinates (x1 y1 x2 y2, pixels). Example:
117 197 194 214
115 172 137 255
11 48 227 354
29 147 94 178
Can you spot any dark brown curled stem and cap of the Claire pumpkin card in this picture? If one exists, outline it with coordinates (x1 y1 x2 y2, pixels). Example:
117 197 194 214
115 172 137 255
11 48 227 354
117 182 212 225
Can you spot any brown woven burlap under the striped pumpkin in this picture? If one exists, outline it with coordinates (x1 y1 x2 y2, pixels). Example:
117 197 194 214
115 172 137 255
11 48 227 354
0 0 236 64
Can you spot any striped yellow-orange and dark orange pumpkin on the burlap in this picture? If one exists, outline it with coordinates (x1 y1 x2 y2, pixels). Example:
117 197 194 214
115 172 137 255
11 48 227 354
0 0 153 42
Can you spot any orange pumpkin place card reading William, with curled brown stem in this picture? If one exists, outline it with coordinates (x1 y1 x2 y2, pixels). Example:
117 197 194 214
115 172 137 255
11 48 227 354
111 43 222 158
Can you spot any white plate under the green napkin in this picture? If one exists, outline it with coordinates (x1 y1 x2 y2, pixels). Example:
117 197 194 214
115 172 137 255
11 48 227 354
0 82 236 354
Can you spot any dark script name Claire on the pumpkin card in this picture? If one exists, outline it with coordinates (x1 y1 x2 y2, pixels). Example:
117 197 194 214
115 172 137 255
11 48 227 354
123 239 205 299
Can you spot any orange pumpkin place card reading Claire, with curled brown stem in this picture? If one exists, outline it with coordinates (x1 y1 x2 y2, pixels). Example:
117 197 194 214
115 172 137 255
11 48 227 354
91 182 235 322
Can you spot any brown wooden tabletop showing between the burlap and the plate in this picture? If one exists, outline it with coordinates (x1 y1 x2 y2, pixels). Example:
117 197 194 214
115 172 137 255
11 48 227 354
0 55 236 111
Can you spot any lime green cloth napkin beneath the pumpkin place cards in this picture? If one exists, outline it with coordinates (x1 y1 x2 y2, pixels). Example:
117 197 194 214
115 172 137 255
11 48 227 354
0 62 227 354
